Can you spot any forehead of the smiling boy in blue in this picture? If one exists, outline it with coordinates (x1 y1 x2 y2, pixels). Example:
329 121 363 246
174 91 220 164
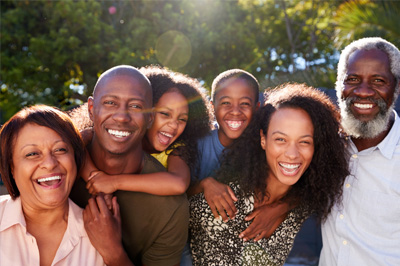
215 77 256 102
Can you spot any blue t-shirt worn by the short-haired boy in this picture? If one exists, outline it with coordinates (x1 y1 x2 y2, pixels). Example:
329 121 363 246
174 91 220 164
192 129 225 181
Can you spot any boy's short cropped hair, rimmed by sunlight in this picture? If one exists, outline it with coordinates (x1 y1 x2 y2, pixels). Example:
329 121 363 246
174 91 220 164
211 69 260 103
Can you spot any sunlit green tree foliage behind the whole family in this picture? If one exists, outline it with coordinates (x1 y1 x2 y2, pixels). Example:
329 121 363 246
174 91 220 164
0 0 400 124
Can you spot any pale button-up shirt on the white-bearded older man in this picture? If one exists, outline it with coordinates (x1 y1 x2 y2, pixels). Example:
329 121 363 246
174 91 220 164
319 110 400 266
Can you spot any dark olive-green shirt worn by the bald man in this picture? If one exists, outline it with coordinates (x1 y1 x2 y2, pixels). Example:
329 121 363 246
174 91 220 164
70 154 189 266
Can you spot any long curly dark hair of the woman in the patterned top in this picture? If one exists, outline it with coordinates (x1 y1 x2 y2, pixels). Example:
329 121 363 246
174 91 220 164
217 84 349 221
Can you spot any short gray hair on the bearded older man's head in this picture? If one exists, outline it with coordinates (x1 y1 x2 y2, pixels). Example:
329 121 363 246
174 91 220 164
336 37 400 102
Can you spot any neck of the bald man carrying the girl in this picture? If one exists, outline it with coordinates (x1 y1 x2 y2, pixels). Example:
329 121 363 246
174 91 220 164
87 141 144 175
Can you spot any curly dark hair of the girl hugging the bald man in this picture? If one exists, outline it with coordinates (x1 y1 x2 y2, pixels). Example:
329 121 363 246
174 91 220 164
140 65 211 169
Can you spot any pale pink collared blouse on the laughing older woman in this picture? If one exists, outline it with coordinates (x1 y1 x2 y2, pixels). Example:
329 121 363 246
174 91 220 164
0 195 105 266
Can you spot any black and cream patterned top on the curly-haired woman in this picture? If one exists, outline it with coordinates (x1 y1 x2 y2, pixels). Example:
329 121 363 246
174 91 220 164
189 184 310 266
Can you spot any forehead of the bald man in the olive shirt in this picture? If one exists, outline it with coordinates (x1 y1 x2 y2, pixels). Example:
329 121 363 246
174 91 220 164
95 75 152 105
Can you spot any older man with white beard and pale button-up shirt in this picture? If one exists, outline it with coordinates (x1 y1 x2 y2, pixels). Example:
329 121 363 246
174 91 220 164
319 38 400 266
